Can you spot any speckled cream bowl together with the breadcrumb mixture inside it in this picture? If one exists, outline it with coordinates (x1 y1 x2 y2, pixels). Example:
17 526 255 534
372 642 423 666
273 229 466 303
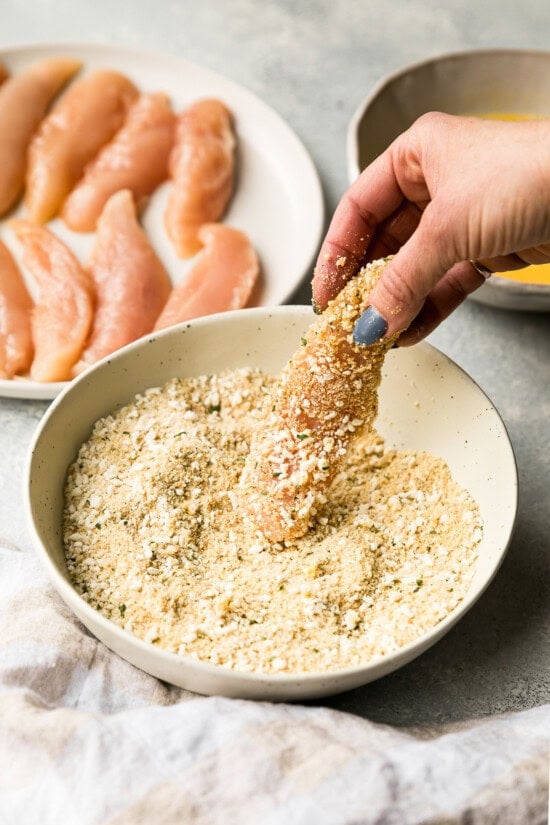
26 306 517 700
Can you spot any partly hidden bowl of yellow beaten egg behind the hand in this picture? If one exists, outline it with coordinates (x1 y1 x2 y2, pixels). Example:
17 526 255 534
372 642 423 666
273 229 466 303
347 49 550 312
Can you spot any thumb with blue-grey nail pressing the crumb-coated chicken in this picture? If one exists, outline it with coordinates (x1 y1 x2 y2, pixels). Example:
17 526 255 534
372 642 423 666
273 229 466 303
353 209 455 346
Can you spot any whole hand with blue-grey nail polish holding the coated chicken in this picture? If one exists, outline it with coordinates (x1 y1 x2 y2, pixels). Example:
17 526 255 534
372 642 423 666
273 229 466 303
313 113 550 346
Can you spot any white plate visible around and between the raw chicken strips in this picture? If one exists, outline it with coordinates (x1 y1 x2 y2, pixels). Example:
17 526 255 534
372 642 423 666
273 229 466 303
0 43 324 399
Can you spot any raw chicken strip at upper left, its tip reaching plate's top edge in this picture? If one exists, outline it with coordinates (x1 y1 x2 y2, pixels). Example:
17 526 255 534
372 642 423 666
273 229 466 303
0 57 82 215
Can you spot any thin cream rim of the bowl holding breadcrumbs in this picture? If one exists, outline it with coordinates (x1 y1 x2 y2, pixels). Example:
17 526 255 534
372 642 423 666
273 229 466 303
23 305 519 684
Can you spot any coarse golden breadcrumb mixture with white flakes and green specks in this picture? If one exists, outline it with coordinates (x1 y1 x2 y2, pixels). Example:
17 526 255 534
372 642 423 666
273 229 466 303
64 369 482 673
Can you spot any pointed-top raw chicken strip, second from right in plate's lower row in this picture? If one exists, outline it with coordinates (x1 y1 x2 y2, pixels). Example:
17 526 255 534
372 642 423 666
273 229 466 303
75 189 171 373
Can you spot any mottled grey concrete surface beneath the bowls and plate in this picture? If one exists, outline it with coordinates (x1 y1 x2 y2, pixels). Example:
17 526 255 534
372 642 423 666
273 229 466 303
0 0 550 725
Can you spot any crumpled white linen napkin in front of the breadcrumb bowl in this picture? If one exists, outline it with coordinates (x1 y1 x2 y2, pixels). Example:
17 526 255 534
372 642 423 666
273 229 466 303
0 545 550 825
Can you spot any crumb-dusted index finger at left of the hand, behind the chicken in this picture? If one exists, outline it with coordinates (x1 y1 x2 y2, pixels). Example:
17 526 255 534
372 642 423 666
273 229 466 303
312 148 404 309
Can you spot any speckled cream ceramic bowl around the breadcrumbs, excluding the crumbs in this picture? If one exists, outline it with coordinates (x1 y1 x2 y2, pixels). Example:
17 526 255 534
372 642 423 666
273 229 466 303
26 307 517 700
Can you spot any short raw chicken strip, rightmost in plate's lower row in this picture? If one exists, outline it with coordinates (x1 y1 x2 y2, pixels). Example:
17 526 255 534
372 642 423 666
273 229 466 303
155 223 260 329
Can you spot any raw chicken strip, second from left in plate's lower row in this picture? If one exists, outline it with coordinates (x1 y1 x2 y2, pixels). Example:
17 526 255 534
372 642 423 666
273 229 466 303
10 219 94 381
